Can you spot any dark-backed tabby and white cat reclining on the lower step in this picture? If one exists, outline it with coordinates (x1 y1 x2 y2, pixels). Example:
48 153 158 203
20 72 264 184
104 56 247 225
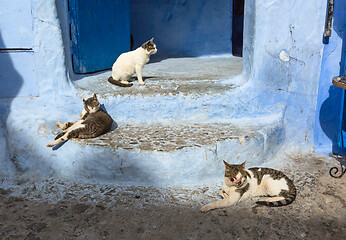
47 94 113 147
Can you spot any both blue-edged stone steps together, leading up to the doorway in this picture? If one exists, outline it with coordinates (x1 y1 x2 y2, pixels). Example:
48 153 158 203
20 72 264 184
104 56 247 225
2 57 285 186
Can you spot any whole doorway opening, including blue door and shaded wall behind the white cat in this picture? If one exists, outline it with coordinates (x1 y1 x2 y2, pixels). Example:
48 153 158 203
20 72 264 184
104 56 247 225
68 0 244 73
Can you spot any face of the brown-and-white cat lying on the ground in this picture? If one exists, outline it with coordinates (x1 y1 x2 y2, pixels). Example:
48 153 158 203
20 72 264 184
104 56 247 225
223 161 247 187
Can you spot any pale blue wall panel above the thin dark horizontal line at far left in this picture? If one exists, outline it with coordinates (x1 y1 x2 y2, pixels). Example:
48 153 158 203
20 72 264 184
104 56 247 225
0 0 34 49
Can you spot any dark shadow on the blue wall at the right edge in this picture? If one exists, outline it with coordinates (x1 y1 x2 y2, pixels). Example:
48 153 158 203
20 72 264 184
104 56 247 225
319 0 346 155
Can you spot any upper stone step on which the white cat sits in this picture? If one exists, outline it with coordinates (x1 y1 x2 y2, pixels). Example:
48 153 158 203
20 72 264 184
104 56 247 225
73 55 242 96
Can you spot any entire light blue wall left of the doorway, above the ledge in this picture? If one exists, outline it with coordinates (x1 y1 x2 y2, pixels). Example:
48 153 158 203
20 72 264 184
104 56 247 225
0 0 71 97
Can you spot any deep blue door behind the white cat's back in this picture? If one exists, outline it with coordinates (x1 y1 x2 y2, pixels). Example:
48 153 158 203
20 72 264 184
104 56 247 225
69 0 130 73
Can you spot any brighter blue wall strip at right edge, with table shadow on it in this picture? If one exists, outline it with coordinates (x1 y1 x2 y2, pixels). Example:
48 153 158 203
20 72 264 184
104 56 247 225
314 0 346 154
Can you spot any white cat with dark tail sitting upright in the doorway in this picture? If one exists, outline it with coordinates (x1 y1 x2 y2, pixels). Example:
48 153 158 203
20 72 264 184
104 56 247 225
108 38 157 87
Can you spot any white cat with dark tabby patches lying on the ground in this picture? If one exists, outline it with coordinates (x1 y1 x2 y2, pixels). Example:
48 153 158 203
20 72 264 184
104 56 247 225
201 161 296 212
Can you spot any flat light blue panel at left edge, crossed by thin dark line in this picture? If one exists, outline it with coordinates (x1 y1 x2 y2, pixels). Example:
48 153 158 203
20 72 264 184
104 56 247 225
0 0 39 97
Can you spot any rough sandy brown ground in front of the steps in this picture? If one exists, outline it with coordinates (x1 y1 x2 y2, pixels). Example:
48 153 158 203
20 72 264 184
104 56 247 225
0 155 346 240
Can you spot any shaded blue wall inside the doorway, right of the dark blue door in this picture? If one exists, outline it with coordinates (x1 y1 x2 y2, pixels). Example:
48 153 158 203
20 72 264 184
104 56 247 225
130 0 232 58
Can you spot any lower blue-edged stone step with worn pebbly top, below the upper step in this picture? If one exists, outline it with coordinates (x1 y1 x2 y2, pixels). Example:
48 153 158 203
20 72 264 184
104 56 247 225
8 116 283 186
